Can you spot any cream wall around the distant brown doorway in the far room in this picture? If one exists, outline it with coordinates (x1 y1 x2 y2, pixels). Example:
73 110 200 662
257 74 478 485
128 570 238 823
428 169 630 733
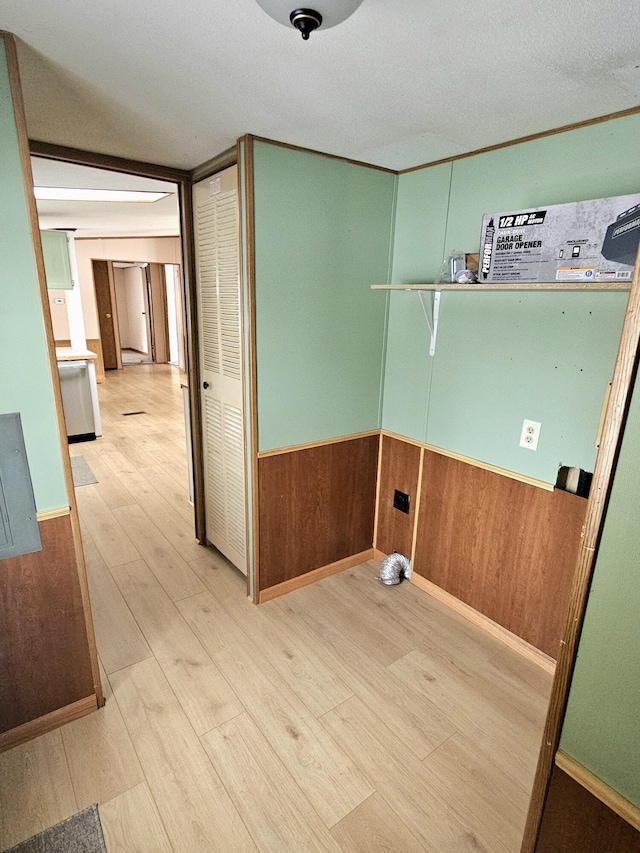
49 237 182 340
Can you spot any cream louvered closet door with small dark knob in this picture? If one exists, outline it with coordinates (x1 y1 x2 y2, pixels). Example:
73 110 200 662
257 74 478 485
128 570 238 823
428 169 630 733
194 166 247 574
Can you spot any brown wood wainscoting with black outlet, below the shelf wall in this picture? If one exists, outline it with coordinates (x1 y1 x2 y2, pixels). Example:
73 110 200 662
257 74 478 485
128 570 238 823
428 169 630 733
376 435 587 659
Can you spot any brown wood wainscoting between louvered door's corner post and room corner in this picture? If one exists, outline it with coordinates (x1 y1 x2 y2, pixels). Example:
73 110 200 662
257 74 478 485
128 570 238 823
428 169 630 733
258 430 379 601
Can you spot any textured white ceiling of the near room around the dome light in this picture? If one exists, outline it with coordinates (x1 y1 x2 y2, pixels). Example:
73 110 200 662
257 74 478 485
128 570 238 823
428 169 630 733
0 0 640 169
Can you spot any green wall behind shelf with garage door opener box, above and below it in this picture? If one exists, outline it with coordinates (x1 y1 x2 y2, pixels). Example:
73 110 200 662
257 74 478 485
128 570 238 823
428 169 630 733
382 115 640 482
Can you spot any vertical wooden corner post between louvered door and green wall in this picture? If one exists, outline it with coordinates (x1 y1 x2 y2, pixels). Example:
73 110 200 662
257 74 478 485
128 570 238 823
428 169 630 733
238 134 261 604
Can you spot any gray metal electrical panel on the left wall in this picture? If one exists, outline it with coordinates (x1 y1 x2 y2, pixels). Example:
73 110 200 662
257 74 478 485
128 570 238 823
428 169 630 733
0 412 42 560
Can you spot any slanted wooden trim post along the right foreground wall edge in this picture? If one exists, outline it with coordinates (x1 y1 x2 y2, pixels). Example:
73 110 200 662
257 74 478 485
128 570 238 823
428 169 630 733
521 243 640 853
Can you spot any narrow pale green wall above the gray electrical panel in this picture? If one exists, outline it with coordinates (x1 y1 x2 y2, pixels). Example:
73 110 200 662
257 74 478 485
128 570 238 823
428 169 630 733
0 39 68 511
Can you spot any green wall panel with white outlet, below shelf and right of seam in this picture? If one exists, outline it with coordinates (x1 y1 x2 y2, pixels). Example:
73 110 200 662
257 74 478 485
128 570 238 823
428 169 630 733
424 292 627 483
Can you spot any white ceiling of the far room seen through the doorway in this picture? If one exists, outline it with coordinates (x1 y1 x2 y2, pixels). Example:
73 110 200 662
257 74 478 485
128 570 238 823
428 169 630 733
31 157 180 237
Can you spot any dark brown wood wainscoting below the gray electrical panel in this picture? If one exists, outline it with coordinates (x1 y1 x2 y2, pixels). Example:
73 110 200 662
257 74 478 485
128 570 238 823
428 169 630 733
0 514 98 751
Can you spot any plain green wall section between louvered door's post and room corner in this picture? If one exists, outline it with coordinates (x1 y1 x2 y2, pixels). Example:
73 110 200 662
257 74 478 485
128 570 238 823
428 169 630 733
254 142 397 450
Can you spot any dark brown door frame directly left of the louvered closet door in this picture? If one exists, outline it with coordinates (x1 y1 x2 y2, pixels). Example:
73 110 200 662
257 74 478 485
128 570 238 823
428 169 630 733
29 140 206 544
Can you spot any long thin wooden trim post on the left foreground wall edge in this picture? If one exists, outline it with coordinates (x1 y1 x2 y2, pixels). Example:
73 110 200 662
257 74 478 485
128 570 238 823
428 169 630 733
1 33 105 707
